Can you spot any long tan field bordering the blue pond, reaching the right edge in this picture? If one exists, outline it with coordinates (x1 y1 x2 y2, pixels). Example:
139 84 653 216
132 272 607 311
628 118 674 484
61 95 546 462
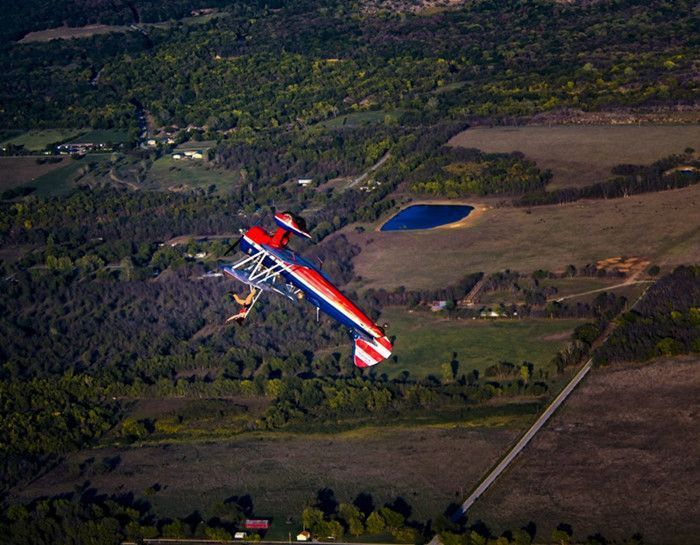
352 186 700 288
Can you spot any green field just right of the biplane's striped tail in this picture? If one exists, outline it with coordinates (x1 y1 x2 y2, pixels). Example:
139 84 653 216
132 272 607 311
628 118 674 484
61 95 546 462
381 308 583 378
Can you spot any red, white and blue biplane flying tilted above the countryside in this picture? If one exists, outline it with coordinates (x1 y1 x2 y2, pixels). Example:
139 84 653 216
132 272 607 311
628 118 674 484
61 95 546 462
221 212 392 368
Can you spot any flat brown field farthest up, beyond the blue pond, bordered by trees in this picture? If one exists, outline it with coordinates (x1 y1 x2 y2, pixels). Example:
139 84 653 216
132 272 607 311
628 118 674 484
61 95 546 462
450 125 700 188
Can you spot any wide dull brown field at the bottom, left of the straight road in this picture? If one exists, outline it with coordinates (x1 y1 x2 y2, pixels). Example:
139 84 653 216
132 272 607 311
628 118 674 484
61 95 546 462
13 422 525 520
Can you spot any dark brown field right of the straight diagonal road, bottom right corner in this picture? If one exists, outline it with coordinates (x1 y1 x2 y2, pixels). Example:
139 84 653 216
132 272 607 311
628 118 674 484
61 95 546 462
469 356 700 544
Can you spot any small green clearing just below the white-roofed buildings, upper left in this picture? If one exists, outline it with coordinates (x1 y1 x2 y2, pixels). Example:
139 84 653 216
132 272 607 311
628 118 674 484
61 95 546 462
144 156 238 193
